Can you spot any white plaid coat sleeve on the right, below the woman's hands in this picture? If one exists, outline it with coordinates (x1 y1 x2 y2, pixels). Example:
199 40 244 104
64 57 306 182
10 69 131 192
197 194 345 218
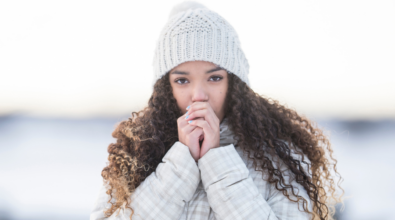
198 144 311 220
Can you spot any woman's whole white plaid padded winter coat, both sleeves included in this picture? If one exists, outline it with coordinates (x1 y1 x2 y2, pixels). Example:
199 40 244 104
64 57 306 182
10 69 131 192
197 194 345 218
90 118 312 220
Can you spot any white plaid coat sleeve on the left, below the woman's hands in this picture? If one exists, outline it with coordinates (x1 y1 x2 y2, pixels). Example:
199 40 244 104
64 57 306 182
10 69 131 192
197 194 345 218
90 141 200 220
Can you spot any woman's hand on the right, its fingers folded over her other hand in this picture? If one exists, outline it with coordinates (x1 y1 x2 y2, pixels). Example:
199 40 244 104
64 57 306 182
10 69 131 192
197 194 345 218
185 102 220 159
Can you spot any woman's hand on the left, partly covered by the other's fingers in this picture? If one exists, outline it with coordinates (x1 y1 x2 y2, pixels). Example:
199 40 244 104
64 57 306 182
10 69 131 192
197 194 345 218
177 111 204 162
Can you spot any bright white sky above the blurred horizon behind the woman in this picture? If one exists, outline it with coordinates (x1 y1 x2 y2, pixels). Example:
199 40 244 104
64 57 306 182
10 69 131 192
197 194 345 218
0 0 395 119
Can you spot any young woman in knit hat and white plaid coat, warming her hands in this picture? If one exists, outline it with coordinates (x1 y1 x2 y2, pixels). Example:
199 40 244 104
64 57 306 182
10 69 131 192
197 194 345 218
90 2 342 220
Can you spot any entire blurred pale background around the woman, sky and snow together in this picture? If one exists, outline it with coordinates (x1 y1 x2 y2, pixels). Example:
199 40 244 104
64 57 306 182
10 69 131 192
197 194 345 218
0 0 395 220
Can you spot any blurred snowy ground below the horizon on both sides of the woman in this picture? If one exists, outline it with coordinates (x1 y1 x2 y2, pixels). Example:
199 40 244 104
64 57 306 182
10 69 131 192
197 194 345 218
0 115 395 220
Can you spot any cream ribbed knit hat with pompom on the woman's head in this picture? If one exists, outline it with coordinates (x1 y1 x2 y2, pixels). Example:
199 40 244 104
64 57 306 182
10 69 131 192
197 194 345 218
153 1 250 86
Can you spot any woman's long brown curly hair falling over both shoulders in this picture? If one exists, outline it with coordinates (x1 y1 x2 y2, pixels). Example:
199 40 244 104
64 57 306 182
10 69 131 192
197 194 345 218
102 73 344 220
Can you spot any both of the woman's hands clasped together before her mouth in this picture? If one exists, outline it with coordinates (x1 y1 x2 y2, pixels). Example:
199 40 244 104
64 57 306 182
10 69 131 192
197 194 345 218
177 102 220 161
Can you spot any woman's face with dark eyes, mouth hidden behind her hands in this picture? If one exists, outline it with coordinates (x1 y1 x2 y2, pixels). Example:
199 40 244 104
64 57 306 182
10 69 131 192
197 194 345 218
169 61 228 121
